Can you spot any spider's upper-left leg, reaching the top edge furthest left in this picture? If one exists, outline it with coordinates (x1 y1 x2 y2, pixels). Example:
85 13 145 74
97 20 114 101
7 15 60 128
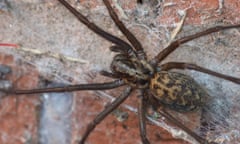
58 0 133 53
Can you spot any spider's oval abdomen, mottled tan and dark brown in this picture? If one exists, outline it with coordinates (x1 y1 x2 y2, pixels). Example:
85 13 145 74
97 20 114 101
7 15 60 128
150 71 208 112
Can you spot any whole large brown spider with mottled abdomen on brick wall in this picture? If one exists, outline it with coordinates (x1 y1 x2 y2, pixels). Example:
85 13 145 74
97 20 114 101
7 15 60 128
1 0 240 144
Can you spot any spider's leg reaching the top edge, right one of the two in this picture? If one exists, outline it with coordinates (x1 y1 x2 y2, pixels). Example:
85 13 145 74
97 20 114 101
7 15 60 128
103 0 146 59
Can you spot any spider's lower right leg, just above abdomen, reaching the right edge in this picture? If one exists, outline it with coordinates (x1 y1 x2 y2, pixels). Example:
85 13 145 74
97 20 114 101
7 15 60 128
160 62 240 84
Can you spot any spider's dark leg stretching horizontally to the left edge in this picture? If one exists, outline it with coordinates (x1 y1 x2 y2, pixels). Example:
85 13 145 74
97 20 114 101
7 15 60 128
0 80 125 95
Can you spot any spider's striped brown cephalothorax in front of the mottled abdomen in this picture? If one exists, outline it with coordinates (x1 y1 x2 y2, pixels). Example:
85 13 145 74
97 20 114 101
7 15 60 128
111 47 154 88
